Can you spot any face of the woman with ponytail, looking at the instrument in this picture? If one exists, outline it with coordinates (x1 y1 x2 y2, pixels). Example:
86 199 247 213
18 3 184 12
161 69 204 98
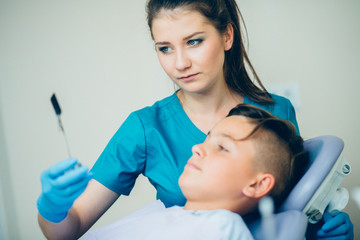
152 8 232 93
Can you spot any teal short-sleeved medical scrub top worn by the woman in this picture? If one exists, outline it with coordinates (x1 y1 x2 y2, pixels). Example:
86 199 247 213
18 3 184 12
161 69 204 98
91 93 298 207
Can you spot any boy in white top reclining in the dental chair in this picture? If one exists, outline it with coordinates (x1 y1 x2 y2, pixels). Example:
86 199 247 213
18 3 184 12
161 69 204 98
84 104 308 240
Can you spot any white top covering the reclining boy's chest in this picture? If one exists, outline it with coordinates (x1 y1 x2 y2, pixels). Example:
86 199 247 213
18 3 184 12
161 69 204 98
83 200 253 240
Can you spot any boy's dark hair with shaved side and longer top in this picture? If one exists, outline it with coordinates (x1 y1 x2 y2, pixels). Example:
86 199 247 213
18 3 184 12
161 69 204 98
228 104 309 207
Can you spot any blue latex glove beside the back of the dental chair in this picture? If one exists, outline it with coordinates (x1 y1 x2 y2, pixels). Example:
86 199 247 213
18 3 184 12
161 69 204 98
317 212 354 240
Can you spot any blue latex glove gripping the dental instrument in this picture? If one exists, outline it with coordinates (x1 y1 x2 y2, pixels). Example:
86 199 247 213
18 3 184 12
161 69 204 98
37 158 92 223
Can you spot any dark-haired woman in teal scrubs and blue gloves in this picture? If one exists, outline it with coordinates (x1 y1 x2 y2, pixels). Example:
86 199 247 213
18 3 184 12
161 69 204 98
37 0 353 239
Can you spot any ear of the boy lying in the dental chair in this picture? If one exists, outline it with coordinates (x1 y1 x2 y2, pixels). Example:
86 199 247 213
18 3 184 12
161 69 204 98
243 173 275 198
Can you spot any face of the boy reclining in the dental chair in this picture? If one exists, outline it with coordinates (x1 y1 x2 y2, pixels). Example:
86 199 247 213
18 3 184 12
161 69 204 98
179 116 256 202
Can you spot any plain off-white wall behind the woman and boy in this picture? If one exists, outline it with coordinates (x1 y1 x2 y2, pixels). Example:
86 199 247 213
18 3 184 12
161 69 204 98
0 0 360 239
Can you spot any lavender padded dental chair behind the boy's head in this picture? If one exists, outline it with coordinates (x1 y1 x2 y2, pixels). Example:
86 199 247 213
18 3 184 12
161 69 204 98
248 135 350 240
